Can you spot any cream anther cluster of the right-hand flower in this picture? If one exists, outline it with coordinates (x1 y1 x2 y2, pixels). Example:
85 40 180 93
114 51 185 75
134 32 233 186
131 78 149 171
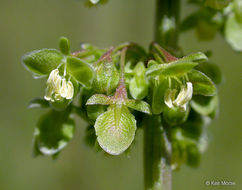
164 82 193 111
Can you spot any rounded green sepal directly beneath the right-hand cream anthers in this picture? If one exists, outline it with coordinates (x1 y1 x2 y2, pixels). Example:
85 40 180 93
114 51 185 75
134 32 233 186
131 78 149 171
163 106 190 126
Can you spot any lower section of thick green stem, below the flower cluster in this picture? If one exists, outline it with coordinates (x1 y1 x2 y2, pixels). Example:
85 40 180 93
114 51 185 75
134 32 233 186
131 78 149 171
144 115 171 190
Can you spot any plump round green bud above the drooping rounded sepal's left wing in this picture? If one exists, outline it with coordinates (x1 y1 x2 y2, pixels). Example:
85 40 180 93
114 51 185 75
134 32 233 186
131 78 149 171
92 61 119 94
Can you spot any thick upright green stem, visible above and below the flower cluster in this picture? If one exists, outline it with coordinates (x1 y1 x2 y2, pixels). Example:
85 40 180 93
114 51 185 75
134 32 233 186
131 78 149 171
144 0 180 190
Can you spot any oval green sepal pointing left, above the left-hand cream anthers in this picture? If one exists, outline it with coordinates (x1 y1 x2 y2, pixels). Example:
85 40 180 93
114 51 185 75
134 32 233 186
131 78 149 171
22 49 64 75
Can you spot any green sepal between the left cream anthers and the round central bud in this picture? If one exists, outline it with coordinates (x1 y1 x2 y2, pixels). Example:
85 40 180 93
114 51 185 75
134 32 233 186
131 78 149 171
67 57 94 88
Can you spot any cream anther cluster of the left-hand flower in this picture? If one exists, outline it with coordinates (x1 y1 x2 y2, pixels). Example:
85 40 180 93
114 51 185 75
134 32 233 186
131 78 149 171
44 69 74 102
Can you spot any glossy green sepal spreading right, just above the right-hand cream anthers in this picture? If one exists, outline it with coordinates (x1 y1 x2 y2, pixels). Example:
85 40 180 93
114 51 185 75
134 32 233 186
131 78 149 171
187 70 216 96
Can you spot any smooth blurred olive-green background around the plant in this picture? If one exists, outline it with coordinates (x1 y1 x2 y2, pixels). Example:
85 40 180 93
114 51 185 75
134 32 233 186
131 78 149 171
0 0 242 190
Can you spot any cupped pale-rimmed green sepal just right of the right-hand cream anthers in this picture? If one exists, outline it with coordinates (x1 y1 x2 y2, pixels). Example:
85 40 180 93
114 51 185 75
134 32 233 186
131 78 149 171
191 95 219 118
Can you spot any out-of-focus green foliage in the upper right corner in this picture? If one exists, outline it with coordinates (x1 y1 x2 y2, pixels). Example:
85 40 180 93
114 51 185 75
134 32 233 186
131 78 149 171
180 0 242 51
